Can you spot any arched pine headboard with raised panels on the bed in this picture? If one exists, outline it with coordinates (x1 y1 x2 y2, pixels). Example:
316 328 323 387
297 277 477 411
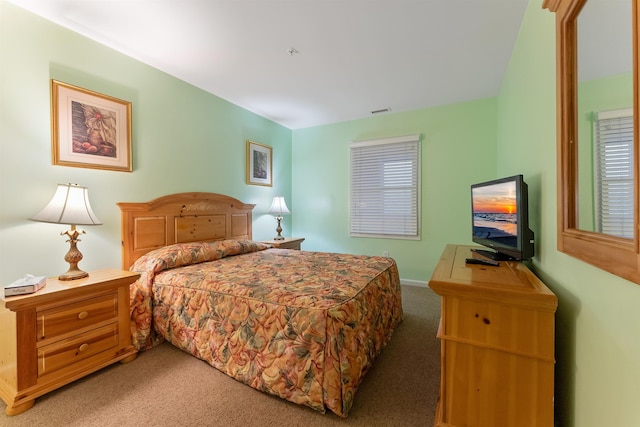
117 193 255 270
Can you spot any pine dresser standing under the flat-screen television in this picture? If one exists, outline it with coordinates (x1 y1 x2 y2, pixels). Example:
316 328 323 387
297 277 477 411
429 245 558 427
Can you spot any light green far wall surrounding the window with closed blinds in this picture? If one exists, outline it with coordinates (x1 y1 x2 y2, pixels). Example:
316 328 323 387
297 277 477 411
292 98 496 284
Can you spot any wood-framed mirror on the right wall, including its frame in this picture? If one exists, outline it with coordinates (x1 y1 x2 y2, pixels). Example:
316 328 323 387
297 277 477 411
542 0 640 283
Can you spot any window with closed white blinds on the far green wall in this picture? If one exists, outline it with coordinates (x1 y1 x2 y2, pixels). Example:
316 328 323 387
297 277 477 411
350 135 420 239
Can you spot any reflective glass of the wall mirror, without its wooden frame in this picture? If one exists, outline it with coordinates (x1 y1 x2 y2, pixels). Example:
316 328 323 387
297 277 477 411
577 0 634 239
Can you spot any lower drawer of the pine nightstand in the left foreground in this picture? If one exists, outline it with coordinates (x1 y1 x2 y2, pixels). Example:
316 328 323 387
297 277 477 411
38 323 118 377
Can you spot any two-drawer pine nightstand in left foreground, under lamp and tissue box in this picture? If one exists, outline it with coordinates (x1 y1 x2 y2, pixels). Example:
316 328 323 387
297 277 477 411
0 270 140 415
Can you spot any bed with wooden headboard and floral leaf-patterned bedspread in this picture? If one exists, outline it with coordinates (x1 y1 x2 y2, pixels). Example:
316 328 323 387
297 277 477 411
118 193 402 417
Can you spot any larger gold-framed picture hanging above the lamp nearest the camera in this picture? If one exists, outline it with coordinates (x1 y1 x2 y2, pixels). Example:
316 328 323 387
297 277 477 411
51 80 132 172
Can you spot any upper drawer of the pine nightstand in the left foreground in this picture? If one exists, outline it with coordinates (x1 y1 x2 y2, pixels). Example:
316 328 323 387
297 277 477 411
37 293 118 341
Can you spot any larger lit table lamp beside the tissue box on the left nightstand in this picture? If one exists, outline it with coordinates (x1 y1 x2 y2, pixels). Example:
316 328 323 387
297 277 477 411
30 184 102 280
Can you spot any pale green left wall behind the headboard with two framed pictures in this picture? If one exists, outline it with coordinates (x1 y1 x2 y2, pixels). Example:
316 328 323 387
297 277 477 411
0 0 291 283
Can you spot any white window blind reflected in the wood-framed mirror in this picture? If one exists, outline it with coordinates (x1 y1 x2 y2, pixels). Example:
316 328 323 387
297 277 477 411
593 109 634 239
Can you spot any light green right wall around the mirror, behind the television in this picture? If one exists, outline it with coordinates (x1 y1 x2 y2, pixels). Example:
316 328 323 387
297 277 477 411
498 0 640 427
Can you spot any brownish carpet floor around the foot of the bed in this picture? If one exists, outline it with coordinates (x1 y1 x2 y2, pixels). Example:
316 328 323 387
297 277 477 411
0 286 440 427
